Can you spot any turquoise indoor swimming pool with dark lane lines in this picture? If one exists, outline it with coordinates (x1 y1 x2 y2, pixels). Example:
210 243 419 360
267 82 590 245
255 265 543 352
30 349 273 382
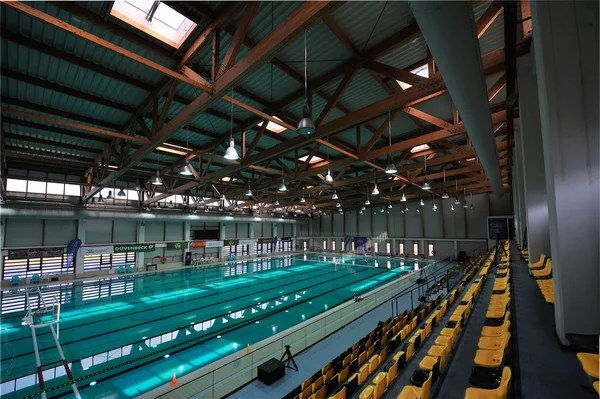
0 254 430 398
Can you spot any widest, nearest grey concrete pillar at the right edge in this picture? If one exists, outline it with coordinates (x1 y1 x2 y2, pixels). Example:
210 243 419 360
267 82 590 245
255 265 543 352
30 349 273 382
531 1 600 345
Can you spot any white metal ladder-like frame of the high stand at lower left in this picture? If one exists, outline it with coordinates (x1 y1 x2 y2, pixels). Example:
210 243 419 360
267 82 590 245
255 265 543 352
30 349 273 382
22 290 81 399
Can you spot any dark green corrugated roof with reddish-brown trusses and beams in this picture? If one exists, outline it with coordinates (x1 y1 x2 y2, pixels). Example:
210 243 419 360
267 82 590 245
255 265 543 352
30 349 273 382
0 1 529 216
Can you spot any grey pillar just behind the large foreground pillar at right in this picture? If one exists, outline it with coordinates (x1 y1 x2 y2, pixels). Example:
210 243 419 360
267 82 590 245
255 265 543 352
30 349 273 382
517 54 550 263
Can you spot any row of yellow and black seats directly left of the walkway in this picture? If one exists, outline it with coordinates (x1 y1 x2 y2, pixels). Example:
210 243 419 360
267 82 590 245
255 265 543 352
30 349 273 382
465 242 511 399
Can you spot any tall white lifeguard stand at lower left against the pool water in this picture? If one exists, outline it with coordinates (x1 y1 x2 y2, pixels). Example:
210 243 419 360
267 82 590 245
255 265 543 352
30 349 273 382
21 287 81 399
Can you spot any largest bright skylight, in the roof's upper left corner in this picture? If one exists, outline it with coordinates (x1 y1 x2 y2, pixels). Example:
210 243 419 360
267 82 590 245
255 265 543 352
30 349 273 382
110 0 196 48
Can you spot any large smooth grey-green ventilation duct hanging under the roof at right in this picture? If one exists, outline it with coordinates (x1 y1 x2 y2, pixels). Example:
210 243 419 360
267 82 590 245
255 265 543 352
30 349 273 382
409 1 504 196
